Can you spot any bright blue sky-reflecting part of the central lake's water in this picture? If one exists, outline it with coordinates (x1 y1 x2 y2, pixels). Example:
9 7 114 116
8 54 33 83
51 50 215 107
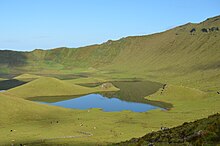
47 94 159 112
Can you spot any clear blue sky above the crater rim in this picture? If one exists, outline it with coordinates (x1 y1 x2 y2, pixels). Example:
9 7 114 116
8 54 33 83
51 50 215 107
0 0 220 51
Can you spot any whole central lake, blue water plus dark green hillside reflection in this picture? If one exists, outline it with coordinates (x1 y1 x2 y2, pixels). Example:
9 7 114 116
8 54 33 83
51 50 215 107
29 81 172 112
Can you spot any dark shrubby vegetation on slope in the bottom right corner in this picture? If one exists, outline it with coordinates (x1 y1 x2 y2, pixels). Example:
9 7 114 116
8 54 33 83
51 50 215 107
114 114 220 146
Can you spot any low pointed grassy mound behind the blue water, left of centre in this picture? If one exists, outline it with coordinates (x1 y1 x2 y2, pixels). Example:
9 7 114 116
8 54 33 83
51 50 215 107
6 77 118 98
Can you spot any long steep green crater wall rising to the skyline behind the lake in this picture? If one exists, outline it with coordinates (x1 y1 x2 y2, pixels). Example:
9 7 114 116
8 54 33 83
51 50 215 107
0 16 220 91
